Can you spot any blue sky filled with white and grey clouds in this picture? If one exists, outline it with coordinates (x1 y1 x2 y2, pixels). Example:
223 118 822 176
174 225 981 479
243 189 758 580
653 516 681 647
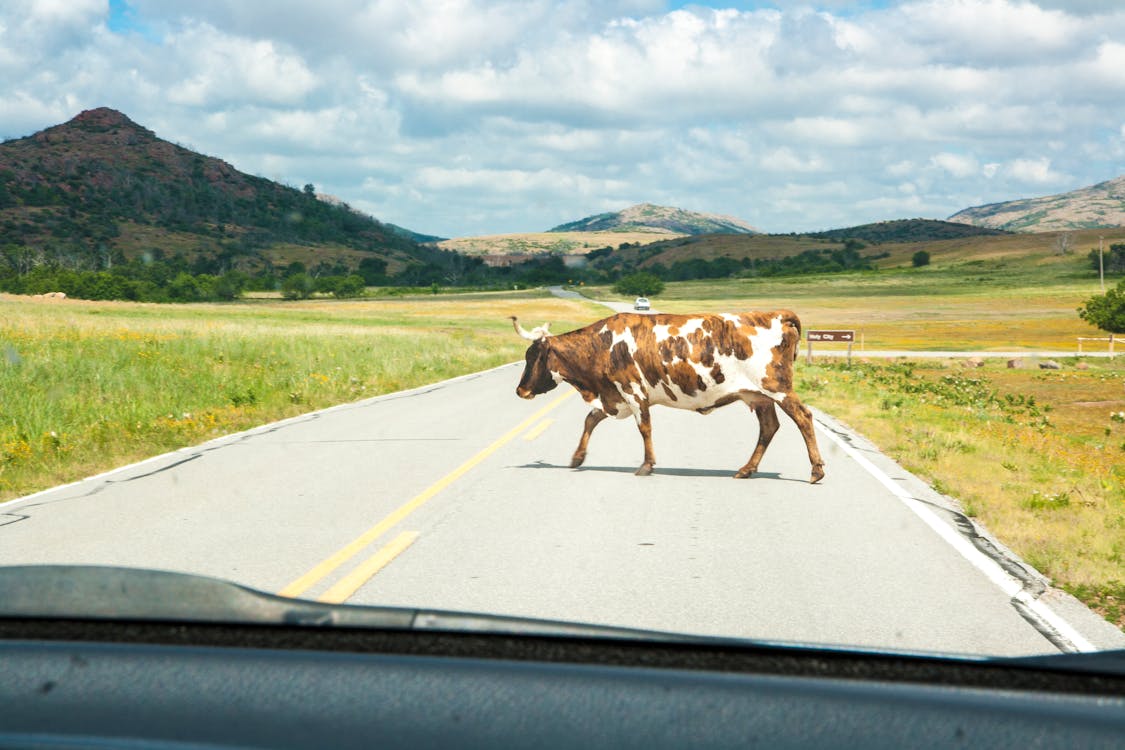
0 0 1125 237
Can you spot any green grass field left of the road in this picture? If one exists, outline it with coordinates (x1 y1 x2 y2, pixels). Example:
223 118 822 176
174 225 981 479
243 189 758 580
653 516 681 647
0 291 600 500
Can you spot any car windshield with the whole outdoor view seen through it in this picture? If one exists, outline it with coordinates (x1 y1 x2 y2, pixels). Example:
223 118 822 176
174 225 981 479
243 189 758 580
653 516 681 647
0 0 1125 657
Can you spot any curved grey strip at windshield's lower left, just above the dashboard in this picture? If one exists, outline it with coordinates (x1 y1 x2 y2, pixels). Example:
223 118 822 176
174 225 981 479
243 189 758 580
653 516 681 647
0 566 695 642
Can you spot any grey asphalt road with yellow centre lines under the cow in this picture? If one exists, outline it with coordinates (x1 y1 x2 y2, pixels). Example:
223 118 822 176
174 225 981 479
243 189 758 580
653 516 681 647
0 357 1125 654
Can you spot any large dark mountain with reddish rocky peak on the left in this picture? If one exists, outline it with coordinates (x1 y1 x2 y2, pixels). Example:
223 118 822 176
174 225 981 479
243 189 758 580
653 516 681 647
0 108 425 270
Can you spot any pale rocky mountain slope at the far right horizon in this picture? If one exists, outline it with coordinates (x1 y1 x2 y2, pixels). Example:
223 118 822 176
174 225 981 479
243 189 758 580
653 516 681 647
950 175 1125 232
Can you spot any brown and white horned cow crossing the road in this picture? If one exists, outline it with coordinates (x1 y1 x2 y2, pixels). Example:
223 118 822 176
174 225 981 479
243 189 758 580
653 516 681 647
512 310 825 482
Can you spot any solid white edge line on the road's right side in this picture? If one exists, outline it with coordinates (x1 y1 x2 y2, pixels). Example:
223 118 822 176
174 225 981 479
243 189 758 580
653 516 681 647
818 425 1098 651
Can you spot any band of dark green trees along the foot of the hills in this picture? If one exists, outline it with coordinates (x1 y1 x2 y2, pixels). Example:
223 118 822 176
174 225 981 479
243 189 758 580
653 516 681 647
0 237 891 302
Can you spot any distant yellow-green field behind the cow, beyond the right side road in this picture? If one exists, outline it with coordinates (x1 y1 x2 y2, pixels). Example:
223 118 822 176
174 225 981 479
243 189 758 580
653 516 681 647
586 249 1105 351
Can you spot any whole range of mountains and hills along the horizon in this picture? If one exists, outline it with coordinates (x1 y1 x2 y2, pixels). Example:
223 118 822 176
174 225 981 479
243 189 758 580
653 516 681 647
0 108 1125 285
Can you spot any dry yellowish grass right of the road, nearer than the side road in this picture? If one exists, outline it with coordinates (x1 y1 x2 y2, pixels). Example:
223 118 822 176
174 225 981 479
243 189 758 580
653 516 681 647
799 359 1125 627
